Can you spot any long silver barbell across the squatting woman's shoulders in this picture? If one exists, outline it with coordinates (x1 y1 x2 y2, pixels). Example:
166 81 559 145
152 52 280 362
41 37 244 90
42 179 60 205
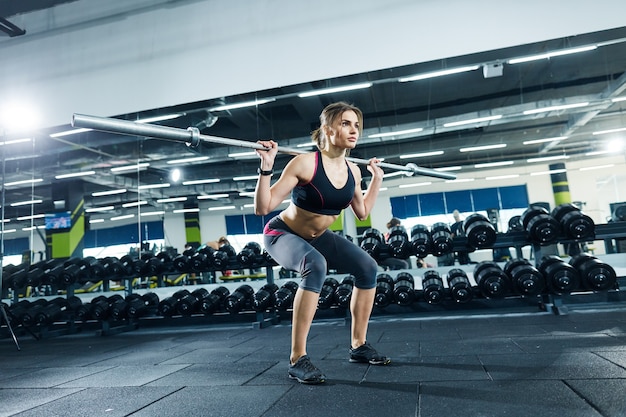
72 113 456 180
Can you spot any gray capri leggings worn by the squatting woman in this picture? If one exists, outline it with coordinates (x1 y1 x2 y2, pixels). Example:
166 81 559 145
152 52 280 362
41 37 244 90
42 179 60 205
263 216 378 293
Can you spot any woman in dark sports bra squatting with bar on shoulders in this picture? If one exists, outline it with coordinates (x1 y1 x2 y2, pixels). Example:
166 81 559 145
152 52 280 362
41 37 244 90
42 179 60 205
254 102 390 384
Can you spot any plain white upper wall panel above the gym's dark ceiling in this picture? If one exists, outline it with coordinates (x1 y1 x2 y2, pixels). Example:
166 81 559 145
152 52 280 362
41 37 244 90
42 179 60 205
0 0 624 127
